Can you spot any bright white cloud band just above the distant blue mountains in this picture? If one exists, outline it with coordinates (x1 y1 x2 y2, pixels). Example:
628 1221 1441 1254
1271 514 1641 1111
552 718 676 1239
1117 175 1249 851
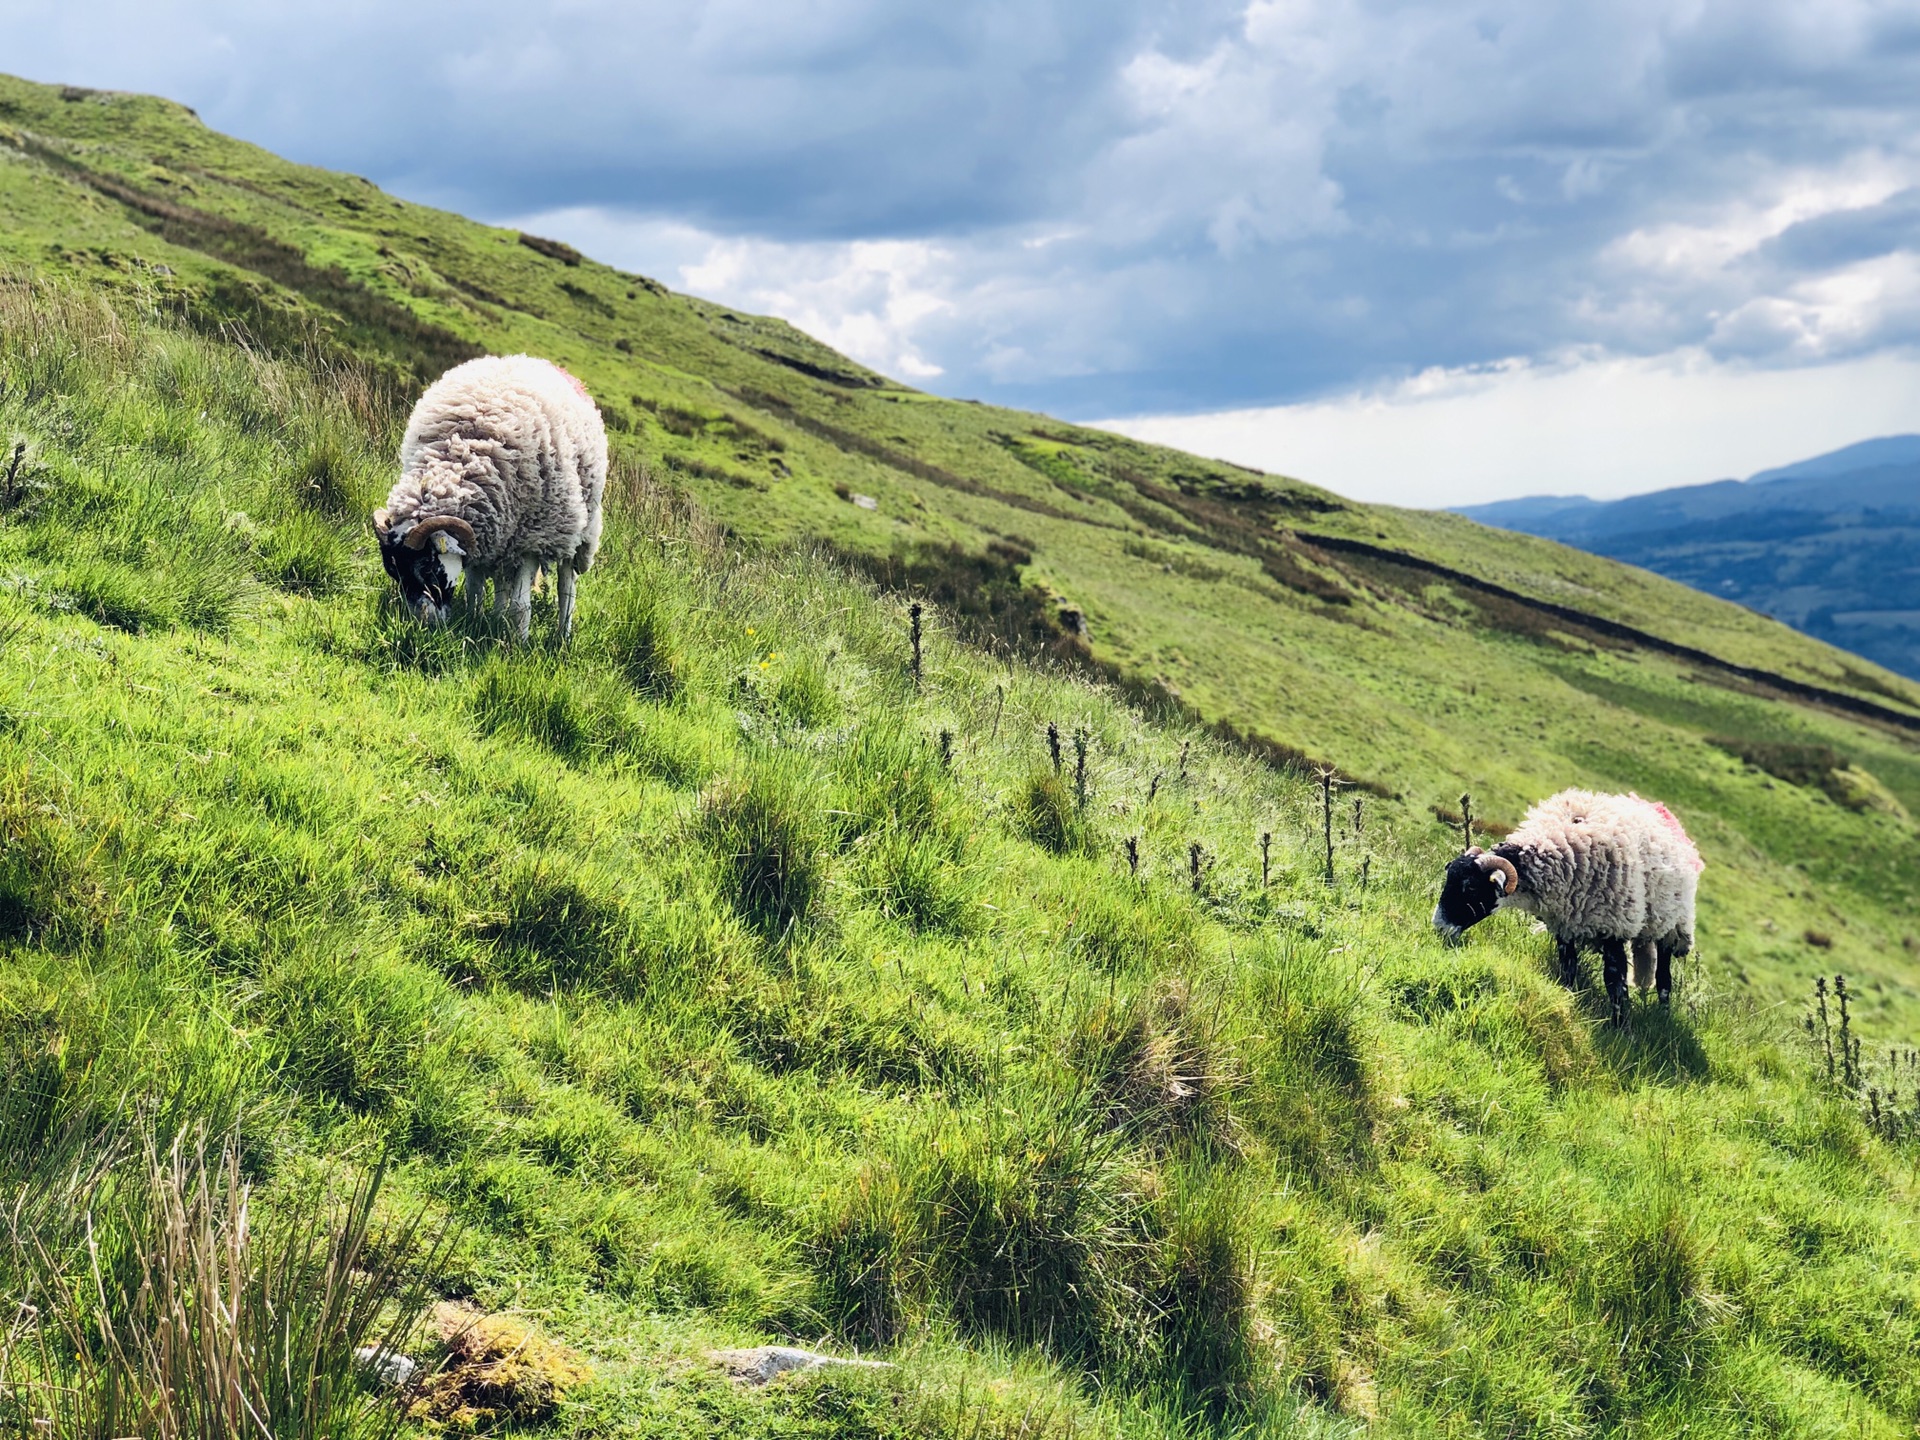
1102 351 1920 507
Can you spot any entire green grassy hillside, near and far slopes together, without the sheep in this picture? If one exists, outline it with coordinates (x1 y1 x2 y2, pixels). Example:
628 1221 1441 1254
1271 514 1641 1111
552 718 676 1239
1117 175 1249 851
0 70 1920 1440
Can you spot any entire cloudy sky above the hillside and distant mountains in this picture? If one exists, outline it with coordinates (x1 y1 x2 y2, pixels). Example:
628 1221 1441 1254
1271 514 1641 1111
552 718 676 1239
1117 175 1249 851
0 0 1920 503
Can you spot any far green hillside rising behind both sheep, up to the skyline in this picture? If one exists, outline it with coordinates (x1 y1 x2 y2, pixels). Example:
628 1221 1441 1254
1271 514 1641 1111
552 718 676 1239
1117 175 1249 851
0 67 1920 1027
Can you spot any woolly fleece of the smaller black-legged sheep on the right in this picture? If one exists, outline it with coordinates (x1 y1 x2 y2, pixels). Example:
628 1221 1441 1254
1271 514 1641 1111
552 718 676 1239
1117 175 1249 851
1500 789 1703 941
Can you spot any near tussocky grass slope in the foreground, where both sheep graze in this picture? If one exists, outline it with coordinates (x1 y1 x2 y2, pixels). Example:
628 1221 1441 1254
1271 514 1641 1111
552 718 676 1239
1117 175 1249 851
0 286 1920 1440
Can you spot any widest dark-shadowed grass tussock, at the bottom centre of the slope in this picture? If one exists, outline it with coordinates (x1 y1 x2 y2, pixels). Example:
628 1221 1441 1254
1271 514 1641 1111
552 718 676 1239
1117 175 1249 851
814 1092 1271 1413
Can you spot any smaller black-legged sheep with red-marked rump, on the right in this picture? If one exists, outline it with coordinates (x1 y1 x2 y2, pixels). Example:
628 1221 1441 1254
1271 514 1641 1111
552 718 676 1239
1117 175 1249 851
1434 789 1703 1025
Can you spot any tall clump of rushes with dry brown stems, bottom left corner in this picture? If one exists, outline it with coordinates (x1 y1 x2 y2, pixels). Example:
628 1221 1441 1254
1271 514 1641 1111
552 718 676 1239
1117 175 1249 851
0 1129 447 1440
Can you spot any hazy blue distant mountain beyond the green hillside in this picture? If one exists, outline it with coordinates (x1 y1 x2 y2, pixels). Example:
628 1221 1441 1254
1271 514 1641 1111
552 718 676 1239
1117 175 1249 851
1459 436 1920 678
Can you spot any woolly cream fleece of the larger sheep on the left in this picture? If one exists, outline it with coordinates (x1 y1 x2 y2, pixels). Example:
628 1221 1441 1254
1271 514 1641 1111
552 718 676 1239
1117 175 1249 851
386 355 607 570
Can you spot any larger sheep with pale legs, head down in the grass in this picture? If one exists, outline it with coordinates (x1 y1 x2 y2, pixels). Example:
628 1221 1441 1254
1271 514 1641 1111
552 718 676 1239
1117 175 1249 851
372 355 607 641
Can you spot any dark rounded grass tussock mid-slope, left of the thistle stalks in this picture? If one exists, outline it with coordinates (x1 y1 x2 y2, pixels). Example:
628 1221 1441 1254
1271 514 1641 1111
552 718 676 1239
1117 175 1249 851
699 751 828 935
